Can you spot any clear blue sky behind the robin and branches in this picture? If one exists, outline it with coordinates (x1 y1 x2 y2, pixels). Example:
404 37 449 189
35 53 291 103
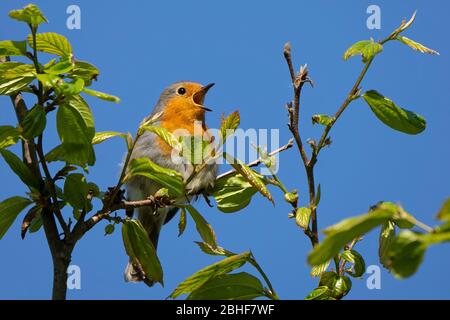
0 0 450 299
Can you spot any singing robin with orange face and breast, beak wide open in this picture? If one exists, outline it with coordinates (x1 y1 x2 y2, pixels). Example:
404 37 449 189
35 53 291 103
121 82 217 286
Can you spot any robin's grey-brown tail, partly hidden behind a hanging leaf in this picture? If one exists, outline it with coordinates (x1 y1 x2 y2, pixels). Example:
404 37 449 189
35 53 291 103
124 208 166 287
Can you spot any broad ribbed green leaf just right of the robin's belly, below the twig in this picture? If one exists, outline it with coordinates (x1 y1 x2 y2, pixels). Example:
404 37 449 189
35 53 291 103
212 174 262 213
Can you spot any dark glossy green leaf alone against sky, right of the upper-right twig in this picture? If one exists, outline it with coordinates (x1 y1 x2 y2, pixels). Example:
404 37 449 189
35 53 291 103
363 90 426 134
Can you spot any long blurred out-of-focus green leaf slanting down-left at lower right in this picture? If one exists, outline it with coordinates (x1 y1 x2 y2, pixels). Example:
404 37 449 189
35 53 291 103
308 208 395 265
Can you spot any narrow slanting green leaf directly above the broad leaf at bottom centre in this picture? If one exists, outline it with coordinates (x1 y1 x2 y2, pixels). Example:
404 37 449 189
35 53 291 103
169 252 251 299
